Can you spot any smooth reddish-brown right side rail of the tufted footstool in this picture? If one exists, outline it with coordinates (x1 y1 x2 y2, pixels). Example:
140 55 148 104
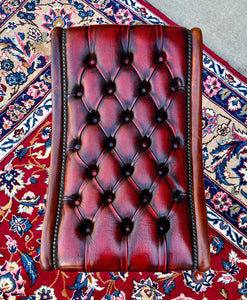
191 28 210 271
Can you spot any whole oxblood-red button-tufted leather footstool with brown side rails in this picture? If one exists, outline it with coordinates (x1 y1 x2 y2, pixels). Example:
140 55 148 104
41 25 209 272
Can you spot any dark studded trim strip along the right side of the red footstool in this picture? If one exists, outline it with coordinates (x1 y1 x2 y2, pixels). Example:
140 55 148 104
187 30 198 269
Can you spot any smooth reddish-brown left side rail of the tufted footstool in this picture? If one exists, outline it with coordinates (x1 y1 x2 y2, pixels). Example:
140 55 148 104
40 27 63 271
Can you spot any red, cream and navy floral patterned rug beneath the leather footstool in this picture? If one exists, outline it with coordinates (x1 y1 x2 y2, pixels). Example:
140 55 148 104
0 0 247 300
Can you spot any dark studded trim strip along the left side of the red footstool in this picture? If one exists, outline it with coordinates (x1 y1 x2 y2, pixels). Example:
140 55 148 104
52 29 67 269
